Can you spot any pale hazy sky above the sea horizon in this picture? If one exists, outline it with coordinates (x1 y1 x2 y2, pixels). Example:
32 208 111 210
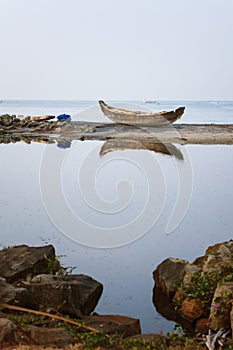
0 0 233 100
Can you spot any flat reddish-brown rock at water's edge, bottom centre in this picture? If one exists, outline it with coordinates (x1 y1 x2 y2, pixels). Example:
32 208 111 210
82 315 141 338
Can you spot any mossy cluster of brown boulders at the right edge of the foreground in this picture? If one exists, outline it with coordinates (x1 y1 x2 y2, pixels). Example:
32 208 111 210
153 240 233 334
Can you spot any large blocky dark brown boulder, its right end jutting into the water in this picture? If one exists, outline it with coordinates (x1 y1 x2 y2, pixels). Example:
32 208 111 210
24 274 103 317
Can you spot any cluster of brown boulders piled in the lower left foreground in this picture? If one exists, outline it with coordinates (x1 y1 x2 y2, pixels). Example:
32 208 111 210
0 245 141 347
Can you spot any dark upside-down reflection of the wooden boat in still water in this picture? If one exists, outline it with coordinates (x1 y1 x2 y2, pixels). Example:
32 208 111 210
100 140 184 160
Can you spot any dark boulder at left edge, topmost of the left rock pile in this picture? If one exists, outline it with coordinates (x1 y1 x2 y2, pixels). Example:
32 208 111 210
0 245 57 283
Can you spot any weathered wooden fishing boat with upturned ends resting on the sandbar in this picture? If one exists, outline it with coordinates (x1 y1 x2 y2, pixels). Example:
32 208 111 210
99 101 185 126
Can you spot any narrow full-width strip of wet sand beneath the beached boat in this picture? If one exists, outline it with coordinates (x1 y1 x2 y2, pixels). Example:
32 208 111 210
0 122 233 145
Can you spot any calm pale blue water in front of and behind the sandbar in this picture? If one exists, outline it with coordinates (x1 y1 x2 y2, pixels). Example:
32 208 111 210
0 101 233 332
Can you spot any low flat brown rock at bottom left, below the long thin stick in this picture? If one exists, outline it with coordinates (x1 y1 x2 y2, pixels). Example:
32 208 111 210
26 326 74 348
